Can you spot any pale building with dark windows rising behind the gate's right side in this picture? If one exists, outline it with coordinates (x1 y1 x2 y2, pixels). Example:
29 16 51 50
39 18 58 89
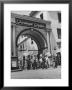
30 11 61 51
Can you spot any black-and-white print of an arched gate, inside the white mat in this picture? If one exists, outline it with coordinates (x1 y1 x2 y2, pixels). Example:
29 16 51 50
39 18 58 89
11 11 61 79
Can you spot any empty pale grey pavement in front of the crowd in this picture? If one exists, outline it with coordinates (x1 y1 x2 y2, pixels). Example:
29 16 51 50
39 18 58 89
11 66 61 79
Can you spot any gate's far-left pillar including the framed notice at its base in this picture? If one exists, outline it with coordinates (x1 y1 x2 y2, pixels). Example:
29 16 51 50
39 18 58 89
11 25 18 70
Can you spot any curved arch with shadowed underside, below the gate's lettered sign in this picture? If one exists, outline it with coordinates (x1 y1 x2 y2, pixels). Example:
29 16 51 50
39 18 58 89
16 28 48 54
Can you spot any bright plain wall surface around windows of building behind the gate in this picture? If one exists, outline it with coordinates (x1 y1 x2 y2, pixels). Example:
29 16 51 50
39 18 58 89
34 11 61 42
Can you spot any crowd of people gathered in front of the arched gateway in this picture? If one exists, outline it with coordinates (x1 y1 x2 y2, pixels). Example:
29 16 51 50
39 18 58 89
18 53 61 70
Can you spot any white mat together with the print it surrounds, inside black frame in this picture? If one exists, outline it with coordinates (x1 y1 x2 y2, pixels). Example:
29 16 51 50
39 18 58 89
4 4 69 86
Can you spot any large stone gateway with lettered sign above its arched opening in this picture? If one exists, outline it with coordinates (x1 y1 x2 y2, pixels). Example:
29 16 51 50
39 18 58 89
11 13 57 67
